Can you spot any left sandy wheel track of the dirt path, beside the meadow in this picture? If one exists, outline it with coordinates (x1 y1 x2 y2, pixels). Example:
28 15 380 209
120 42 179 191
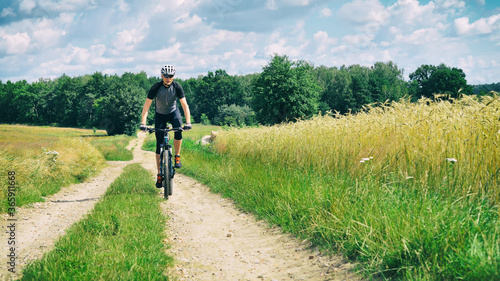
0 135 143 280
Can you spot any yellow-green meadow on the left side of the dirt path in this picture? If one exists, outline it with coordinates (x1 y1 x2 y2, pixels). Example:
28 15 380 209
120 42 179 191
0 125 132 213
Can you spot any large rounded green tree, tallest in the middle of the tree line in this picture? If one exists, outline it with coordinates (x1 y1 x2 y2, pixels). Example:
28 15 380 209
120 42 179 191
253 54 320 125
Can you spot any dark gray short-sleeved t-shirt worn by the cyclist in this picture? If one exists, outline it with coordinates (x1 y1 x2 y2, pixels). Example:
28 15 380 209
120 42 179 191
148 81 184 114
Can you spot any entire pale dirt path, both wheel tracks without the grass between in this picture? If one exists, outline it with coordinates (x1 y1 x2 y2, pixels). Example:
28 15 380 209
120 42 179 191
0 134 359 280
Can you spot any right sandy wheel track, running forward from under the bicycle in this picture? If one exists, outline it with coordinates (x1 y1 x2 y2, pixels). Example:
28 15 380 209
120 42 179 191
163 175 359 280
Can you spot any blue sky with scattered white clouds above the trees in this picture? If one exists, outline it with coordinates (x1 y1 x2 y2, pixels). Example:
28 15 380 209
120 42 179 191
0 0 500 84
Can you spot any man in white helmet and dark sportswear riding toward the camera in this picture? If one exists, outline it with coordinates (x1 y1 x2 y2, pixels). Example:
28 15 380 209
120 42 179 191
140 65 191 188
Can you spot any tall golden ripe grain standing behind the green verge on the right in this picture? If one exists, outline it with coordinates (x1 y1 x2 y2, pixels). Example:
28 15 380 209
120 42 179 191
217 95 500 203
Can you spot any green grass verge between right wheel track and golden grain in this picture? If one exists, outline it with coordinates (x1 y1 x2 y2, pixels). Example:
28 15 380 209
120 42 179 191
182 145 500 280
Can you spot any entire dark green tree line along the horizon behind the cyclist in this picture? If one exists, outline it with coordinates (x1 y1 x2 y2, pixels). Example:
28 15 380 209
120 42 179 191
0 55 484 135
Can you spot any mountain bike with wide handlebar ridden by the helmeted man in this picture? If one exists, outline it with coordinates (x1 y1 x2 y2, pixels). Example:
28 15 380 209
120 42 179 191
146 127 183 199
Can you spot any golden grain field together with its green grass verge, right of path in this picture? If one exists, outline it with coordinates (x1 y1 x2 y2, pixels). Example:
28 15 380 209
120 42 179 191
177 95 500 280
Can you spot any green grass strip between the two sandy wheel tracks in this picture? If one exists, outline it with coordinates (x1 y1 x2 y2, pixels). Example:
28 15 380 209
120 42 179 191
22 164 172 280
